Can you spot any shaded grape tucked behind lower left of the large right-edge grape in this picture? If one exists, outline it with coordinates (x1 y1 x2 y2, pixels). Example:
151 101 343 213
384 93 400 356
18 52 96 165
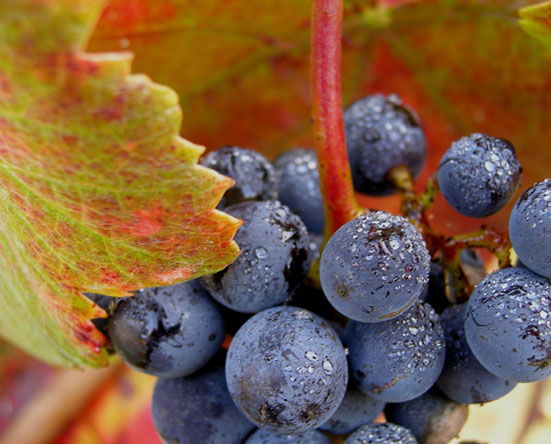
437 304 516 404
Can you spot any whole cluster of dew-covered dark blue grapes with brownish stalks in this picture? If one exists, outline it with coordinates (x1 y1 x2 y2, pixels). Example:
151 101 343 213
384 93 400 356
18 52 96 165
89 94 551 444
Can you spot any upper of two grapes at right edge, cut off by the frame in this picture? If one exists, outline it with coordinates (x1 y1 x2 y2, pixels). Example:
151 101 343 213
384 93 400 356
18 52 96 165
509 179 551 278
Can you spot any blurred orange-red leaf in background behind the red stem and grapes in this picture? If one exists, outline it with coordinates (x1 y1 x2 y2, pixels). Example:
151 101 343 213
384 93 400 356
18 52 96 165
88 0 551 236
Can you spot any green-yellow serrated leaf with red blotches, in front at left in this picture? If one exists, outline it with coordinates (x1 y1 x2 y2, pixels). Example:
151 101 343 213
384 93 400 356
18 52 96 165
0 0 239 366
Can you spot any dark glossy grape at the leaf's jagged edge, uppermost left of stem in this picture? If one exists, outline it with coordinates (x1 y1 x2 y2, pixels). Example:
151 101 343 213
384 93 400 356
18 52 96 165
201 146 277 208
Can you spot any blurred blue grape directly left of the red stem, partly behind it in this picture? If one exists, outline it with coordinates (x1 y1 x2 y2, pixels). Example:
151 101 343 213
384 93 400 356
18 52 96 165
274 149 324 233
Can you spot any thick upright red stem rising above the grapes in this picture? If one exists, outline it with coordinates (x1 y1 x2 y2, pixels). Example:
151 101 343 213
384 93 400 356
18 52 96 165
311 0 360 240
